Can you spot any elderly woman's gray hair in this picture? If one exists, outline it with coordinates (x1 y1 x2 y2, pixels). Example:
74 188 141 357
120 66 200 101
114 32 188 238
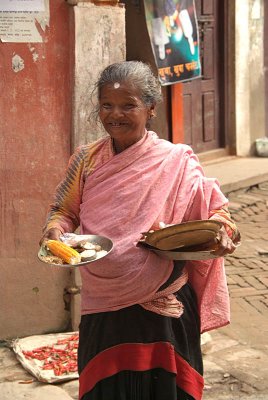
96 61 162 106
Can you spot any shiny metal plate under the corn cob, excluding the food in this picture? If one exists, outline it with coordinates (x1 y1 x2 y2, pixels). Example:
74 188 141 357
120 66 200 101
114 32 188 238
37 235 113 268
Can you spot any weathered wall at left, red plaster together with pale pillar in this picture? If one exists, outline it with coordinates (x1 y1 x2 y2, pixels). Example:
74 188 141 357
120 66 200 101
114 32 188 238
0 0 125 339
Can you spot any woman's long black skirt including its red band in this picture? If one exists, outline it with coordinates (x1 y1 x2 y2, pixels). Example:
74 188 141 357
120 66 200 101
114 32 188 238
78 267 204 400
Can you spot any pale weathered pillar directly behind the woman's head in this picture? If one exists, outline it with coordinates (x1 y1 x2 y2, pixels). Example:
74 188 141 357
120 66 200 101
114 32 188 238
73 2 126 147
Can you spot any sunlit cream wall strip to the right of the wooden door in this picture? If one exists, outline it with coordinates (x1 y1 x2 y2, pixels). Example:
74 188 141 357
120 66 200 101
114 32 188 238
235 0 265 156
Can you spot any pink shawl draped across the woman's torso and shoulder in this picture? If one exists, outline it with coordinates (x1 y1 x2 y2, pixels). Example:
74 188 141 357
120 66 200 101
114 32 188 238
80 132 229 331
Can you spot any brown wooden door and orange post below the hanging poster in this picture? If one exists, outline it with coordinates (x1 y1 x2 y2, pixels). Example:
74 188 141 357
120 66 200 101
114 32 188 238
171 0 226 153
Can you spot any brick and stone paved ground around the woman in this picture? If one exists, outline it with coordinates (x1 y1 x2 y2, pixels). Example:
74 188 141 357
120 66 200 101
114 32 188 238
0 182 268 400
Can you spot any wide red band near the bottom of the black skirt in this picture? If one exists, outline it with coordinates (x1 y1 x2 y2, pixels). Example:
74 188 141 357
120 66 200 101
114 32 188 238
79 342 204 400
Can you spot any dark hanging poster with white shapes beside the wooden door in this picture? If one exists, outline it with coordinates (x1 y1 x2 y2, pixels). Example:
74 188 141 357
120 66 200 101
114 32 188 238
144 0 201 86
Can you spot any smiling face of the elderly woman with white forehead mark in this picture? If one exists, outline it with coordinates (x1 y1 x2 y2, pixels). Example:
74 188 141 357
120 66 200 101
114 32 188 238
99 83 154 148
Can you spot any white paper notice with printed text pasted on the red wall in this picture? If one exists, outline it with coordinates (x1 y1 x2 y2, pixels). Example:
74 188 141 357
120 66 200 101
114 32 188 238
0 0 49 43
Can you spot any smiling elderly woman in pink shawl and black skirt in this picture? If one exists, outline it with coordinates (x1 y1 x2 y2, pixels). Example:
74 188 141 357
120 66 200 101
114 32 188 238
41 61 241 400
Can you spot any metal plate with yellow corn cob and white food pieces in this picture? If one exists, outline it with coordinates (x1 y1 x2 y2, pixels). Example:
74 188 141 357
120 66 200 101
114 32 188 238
38 235 113 268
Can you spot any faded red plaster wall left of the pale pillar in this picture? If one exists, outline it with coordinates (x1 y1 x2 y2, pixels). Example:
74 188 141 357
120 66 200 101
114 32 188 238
0 0 73 338
